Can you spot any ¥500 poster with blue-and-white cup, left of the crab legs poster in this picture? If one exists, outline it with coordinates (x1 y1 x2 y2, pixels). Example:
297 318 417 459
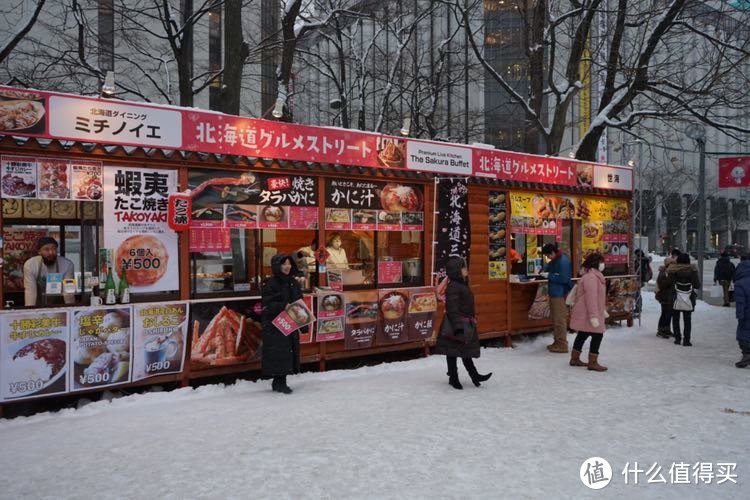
133 302 188 381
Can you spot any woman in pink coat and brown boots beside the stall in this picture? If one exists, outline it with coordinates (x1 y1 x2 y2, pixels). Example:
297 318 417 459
570 253 607 372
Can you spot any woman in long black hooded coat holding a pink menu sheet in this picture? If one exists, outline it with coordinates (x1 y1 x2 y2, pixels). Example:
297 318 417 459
261 254 302 394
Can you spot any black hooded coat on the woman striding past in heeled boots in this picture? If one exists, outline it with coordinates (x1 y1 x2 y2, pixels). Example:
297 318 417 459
433 258 479 358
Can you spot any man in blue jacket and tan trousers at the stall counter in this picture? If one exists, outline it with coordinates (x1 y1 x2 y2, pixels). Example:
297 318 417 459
541 243 573 353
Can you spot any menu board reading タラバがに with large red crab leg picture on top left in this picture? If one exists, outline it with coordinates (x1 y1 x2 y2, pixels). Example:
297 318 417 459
188 170 318 229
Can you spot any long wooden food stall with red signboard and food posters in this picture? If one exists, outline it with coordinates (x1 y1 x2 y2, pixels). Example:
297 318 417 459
0 87 632 414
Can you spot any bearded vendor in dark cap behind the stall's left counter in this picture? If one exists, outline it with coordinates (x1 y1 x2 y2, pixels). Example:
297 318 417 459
23 236 75 307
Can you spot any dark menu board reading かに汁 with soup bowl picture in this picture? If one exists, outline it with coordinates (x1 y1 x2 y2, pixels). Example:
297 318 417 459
325 179 424 231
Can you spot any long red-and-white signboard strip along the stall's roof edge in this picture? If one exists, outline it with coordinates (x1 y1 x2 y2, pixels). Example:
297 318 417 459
0 86 633 191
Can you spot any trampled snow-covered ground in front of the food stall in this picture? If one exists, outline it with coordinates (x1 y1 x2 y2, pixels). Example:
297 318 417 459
0 292 750 499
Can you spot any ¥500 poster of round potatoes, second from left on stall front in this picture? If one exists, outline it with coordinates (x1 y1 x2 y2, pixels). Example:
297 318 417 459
70 307 132 391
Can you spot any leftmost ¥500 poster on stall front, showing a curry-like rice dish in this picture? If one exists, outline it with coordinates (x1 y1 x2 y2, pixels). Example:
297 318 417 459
0 311 69 401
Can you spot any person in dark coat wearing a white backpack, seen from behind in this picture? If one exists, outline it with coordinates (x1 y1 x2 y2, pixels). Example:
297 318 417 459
667 253 701 346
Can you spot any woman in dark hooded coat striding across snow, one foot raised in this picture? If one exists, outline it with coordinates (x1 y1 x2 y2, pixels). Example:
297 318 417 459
433 257 492 389
